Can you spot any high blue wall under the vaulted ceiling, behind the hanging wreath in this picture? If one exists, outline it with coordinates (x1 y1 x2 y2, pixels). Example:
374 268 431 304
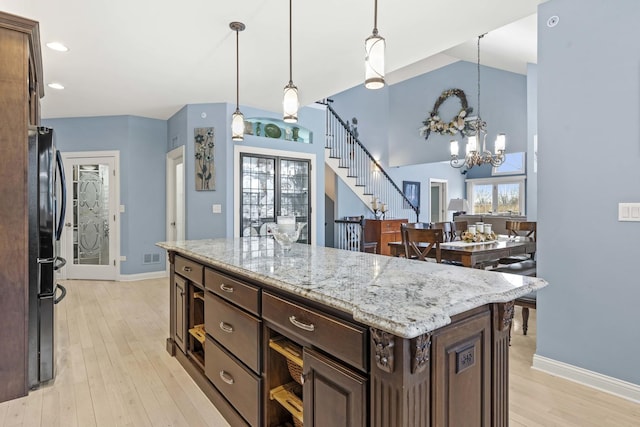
389 61 527 166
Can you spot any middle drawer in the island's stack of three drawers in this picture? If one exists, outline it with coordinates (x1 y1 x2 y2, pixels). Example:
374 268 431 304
204 292 260 372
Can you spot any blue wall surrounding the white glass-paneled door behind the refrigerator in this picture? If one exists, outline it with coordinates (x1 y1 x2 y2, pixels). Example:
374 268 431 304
43 116 167 274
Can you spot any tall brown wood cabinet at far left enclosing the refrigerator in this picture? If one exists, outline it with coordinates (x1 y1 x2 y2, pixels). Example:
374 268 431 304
0 12 44 402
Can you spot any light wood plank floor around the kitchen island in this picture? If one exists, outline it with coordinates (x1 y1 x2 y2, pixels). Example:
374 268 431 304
0 279 640 427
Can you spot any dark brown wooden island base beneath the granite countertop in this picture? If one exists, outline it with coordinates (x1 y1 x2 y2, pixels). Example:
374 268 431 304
168 252 513 427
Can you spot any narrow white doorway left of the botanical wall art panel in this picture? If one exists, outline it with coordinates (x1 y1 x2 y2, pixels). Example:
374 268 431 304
166 145 186 249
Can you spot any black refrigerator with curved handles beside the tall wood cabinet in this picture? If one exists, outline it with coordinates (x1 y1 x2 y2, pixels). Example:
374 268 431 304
27 127 66 389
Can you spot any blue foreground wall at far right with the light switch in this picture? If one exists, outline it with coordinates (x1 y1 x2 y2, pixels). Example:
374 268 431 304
537 0 640 385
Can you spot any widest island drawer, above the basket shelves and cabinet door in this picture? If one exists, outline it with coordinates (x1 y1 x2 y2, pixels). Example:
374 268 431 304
262 292 366 370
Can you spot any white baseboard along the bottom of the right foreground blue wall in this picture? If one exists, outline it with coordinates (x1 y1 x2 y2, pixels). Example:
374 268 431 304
532 354 640 403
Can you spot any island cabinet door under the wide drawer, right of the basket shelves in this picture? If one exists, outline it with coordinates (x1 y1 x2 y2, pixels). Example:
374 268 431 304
303 348 367 427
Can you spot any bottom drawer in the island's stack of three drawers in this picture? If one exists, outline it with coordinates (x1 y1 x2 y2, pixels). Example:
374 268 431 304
204 337 261 426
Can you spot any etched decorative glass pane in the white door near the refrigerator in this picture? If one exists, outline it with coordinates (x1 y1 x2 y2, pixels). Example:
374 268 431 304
73 164 110 265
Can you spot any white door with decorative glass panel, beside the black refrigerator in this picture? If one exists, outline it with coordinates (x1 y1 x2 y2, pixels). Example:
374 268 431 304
60 152 120 280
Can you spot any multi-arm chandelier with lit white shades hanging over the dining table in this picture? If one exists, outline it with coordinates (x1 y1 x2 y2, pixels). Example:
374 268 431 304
450 34 506 169
